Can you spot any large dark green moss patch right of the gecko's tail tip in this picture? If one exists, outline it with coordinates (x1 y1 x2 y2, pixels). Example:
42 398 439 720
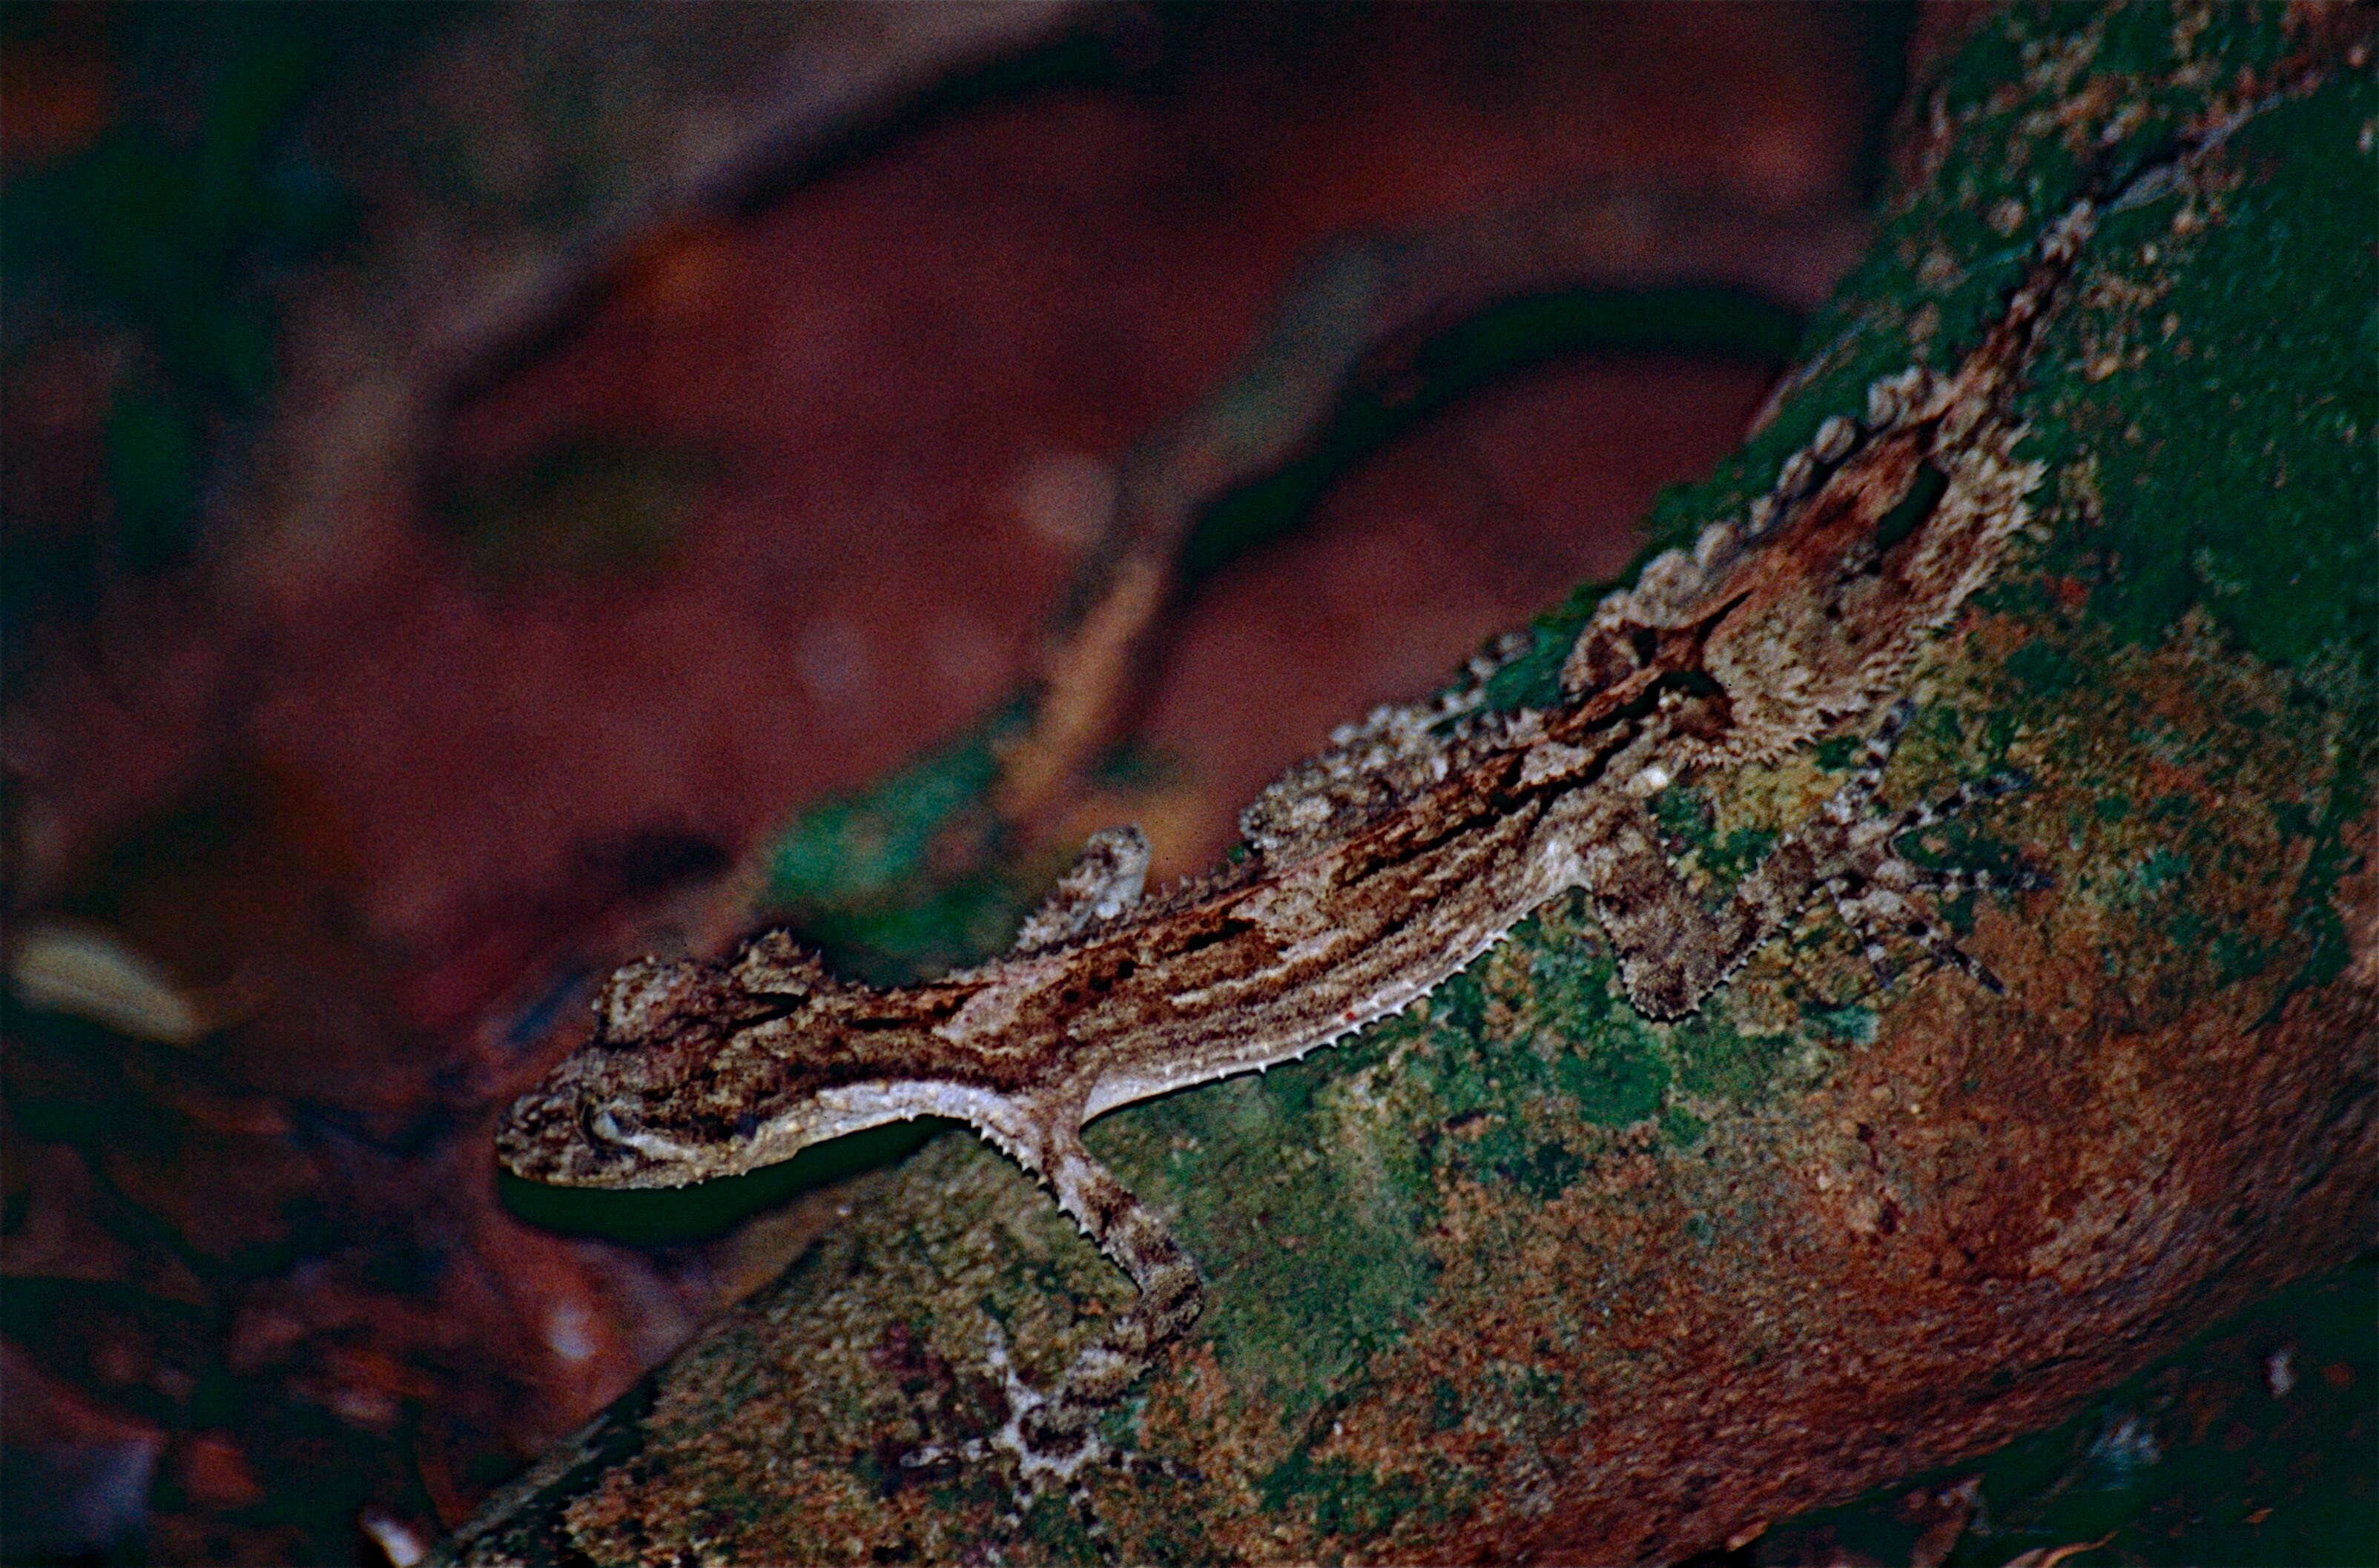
2039 71 2379 669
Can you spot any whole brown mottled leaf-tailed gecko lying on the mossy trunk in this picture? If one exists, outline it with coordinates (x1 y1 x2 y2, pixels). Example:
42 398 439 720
497 129 2243 1518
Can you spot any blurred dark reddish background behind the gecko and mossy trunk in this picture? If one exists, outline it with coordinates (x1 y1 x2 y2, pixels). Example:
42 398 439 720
0 0 2379 1564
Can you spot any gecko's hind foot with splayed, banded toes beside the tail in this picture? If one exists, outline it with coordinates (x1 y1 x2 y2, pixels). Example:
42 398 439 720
1825 697 2056 995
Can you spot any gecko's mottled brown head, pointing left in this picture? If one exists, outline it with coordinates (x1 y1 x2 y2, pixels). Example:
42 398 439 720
495 933 894 1187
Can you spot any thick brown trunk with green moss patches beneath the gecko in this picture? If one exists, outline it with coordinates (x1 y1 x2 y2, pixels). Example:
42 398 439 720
438 7 2379 1564
